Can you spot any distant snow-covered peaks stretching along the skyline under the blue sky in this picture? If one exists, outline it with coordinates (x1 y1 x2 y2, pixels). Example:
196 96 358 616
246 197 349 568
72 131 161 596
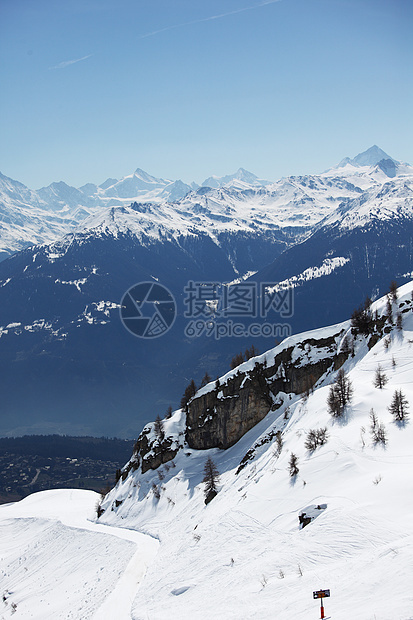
0 147 413 257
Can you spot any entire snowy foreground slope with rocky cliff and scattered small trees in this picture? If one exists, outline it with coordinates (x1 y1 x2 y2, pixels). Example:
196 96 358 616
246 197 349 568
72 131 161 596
0 282 413 620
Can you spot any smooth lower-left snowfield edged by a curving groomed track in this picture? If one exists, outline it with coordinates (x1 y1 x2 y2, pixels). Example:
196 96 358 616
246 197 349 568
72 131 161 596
0 490 159 620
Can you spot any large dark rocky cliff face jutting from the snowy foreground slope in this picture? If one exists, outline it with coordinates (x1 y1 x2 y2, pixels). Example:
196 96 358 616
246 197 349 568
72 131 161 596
186 328 350 450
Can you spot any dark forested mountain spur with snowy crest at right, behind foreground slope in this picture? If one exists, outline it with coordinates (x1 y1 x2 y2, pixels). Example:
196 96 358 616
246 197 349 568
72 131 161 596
245 178 413 331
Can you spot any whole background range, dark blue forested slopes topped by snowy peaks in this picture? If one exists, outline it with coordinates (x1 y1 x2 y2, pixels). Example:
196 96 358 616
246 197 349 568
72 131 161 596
0 148 413 437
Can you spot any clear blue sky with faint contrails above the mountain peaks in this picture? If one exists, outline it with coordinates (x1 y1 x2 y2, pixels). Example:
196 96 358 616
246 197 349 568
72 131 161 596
0 0 413 189
